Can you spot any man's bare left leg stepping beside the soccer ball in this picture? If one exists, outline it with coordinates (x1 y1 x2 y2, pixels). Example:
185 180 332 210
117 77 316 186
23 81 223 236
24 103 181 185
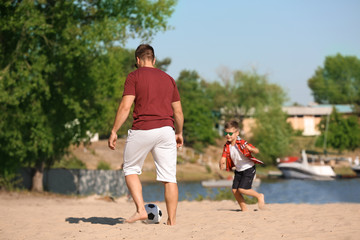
125 174 147 223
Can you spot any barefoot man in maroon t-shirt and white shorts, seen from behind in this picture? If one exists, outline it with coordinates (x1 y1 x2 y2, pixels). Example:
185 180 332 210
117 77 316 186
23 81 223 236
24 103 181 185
108 44 184 225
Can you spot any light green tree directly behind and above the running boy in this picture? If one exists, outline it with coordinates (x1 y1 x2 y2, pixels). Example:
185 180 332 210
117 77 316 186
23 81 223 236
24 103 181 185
217 71 292 164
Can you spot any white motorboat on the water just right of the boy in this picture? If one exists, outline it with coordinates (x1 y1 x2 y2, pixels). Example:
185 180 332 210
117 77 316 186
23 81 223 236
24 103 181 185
277 150 336 180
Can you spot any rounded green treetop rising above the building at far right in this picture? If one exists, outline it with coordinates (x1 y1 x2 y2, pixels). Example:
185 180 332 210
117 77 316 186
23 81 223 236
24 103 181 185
308 54 360 105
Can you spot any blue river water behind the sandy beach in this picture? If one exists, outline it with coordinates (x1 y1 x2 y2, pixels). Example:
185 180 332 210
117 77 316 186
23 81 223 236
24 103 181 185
143 178 360 204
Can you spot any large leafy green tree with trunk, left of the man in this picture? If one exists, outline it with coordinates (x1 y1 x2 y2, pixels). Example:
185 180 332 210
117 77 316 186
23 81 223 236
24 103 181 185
0 0 175 191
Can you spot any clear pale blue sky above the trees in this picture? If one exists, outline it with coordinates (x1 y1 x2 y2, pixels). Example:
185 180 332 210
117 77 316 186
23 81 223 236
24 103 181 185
126 0 360 105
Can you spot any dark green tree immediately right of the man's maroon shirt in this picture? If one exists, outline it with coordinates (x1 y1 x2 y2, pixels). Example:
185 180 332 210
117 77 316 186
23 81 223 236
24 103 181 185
176 70 216 150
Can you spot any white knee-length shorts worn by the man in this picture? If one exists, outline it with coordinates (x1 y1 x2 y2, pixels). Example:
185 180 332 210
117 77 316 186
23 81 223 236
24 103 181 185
124 127 177 183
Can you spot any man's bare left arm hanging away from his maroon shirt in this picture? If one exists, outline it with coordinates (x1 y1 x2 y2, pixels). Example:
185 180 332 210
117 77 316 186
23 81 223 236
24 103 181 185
108 95 135 150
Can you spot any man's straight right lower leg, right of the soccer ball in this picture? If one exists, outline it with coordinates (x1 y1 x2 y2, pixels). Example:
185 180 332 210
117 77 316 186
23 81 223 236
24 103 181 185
164 182 179 225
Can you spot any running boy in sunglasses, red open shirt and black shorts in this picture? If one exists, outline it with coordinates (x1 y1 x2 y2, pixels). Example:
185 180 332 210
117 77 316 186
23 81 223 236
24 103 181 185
219 121 265 211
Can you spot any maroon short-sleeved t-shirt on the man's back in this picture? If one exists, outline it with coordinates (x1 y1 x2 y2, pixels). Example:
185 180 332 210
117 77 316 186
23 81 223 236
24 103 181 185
123 67 180 130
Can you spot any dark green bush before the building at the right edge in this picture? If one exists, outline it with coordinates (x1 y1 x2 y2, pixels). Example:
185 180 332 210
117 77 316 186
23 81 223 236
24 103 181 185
316 108 360 152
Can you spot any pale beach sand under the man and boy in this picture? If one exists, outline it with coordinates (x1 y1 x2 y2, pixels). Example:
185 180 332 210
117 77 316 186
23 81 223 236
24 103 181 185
0 192 360 240
